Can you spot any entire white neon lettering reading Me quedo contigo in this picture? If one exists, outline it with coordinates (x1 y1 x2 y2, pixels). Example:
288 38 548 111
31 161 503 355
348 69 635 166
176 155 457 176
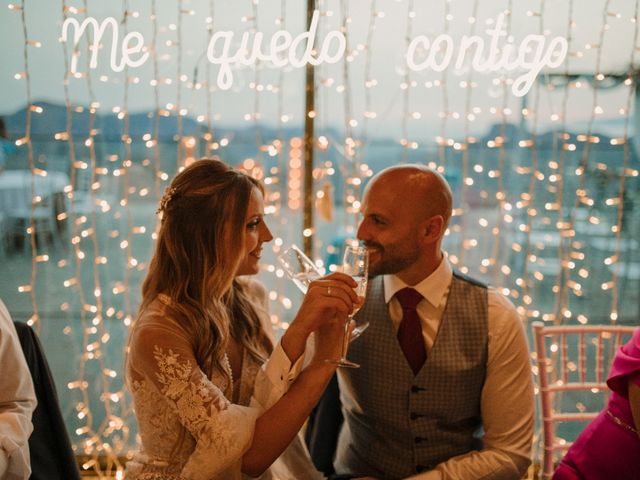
62 10 569 97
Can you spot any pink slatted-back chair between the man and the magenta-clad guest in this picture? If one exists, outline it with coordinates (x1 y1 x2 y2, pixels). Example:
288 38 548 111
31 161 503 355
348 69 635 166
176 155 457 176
533 322 637 479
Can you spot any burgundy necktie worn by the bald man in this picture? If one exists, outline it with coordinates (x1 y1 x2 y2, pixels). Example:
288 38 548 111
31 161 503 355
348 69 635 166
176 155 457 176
396 288 427 375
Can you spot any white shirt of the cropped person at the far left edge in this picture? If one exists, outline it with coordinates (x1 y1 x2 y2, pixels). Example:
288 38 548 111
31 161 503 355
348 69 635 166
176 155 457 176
0 300 37 480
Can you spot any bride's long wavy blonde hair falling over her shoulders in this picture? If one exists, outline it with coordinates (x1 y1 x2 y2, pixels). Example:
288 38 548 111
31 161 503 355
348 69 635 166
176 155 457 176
140 159 273 375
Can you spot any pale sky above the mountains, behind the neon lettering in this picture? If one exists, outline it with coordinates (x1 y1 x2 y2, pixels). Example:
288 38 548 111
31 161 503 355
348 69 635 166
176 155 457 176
0 0 637 138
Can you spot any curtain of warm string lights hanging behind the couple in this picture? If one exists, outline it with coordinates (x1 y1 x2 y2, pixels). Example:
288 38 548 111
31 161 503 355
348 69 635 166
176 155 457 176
0 0 640 477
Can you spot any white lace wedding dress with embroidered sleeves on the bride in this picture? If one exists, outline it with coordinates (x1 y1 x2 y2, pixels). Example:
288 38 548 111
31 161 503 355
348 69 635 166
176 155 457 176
126 282 324 480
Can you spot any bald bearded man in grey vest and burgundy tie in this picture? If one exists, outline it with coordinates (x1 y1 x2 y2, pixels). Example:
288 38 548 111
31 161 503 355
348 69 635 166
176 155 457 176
311 165 534 480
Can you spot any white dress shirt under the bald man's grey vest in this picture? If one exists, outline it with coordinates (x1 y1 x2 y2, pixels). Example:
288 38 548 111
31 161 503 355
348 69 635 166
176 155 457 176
383 257 534 480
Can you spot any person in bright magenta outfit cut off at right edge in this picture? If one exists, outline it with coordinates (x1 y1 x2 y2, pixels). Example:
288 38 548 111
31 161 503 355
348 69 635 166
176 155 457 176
553 328 640 480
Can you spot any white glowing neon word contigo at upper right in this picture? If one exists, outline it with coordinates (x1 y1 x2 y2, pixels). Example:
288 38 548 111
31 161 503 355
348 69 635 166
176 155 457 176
407 13 569 97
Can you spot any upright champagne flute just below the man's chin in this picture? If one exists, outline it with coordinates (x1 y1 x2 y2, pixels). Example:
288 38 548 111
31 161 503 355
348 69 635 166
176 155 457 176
327 245 369 368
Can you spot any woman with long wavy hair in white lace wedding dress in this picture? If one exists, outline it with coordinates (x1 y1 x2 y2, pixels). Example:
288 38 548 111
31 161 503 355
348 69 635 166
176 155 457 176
126 159 358 480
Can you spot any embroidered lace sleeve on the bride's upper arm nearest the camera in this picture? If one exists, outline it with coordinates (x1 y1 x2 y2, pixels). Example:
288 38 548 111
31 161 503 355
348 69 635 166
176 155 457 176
129 324 261 479
